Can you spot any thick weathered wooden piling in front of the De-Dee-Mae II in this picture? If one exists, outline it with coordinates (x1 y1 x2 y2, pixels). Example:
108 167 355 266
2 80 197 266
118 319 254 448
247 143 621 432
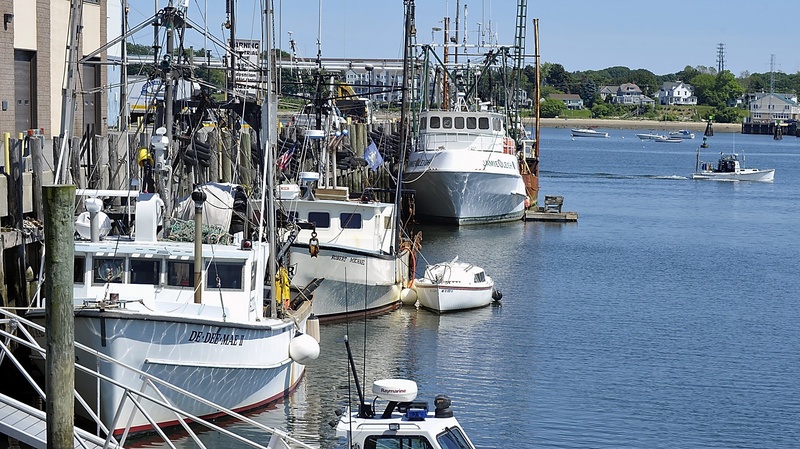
42 185 75 448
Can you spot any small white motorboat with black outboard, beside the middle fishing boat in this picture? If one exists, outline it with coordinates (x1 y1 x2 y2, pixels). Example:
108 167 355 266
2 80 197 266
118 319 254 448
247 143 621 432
404 256 502 313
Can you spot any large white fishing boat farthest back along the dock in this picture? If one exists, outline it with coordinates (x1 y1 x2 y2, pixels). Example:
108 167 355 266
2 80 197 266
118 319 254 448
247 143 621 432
403 95 530 225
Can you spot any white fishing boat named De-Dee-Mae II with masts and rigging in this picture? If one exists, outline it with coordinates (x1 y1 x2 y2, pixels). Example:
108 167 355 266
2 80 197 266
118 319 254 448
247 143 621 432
29 2 319 435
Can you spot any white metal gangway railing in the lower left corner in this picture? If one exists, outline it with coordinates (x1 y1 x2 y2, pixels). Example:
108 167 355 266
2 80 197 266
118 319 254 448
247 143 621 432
0 308 315 449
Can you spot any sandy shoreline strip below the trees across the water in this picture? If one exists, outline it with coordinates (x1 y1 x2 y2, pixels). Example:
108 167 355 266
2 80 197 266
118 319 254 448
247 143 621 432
523 118 742 133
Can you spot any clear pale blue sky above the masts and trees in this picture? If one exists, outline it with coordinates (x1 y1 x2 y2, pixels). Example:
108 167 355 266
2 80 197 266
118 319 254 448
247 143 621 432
125 0 800 76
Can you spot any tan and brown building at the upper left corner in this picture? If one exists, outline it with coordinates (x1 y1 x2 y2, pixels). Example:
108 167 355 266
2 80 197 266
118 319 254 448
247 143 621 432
0 0 108 139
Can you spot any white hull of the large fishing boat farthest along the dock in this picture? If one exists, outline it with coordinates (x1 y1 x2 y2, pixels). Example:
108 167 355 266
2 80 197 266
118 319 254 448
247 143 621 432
404 151 526 225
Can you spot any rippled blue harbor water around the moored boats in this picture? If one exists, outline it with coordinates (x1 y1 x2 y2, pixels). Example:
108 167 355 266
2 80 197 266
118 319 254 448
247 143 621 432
139 129 800 448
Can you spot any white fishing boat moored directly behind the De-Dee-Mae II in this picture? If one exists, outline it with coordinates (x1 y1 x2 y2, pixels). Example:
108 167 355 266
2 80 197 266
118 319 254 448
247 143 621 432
280 172 412 321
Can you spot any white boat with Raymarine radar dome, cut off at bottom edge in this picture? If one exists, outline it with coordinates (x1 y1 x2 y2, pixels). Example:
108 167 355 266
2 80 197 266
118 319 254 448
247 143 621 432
331 336 475 449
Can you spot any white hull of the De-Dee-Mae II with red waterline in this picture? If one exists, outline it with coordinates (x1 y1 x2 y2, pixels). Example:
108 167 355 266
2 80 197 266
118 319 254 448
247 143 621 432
32 304 310 435
